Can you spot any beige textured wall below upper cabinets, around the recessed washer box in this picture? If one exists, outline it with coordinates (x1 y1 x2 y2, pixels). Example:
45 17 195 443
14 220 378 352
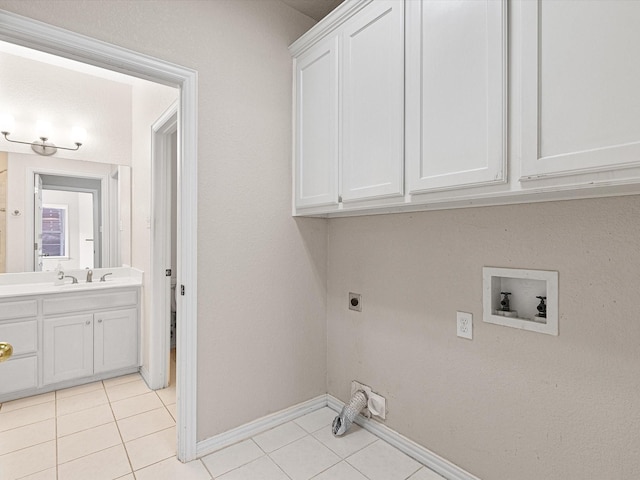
327 196 640 480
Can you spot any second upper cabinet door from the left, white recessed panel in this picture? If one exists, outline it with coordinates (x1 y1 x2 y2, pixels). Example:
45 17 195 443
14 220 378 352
341 0 404 203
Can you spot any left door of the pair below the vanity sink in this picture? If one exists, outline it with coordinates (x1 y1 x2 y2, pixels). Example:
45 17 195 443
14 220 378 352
43 314 93 385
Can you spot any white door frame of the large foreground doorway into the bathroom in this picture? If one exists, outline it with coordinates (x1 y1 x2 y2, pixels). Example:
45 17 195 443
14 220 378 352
0 11 198 462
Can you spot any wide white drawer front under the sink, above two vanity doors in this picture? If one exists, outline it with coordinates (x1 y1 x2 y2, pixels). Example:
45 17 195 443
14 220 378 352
42 288 138 315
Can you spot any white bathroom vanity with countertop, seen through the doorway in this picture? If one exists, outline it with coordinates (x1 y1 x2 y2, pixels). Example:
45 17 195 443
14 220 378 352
0 267 142 402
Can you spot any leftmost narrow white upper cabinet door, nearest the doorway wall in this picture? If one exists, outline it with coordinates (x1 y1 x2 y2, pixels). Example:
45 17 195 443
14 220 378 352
294 37 338 208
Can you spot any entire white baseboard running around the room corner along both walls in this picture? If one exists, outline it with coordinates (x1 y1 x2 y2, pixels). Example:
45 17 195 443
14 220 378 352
196 395 480 480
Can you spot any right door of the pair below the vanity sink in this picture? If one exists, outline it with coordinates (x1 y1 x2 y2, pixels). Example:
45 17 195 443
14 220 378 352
93 308 138 373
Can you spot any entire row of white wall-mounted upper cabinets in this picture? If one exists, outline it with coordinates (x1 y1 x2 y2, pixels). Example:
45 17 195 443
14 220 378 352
290 0 640 217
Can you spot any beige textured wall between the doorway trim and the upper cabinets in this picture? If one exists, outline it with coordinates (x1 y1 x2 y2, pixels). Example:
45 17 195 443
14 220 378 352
0 0 326 439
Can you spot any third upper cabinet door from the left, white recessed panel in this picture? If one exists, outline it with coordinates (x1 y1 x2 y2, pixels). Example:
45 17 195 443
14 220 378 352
406 0 507 193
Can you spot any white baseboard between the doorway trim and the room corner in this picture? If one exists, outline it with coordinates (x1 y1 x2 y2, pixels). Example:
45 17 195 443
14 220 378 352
196 395 327 458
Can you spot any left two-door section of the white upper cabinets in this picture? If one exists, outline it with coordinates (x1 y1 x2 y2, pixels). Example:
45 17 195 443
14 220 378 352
290 0 404 213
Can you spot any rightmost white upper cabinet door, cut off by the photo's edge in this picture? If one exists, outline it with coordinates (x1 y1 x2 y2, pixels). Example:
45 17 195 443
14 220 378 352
520 0 640 183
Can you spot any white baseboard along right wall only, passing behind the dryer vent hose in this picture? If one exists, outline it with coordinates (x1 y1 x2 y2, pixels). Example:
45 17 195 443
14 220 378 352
327 395 480 480
